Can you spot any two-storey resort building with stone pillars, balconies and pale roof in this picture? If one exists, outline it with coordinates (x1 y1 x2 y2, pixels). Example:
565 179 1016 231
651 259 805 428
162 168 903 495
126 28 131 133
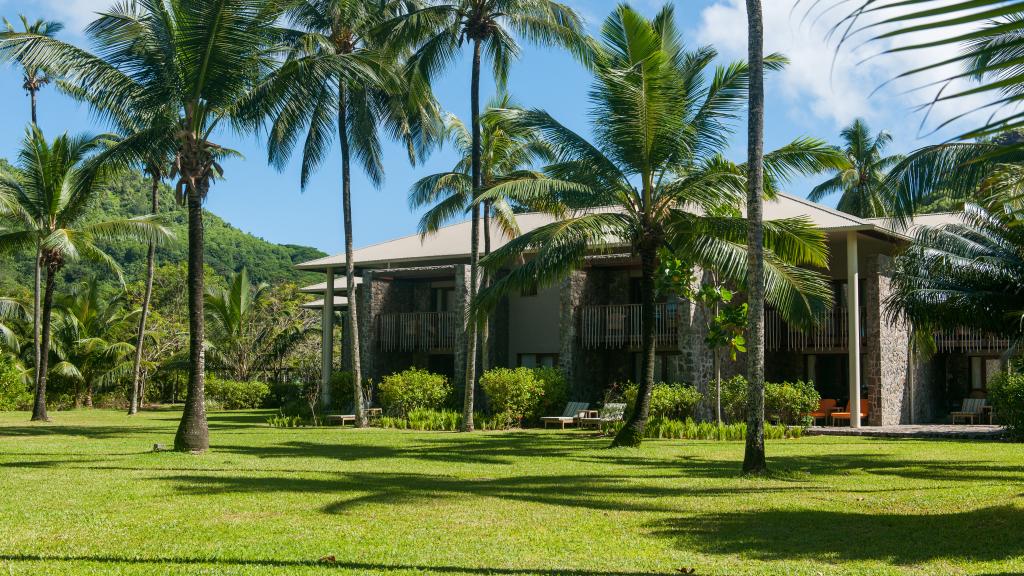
298 195 1008 425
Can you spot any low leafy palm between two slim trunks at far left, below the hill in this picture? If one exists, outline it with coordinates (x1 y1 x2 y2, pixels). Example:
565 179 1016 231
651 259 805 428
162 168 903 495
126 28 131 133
50 279 135 408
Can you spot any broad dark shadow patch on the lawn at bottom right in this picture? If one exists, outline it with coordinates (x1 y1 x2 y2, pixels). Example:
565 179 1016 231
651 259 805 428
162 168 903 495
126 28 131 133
650 505 1024 565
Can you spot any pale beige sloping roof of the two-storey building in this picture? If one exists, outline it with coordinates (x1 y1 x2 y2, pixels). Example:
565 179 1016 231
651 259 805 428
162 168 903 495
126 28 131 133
296 194 948 272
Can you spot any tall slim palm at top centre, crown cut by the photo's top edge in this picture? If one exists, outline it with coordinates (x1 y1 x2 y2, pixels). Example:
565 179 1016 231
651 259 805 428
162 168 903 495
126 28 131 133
386 0 590 431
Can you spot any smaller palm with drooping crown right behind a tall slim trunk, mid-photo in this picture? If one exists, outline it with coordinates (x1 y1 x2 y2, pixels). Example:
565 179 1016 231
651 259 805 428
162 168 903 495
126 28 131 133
409 89 554 371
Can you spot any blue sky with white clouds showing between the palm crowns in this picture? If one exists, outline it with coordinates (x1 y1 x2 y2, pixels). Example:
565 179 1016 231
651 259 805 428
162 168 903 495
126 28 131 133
0 0 974 253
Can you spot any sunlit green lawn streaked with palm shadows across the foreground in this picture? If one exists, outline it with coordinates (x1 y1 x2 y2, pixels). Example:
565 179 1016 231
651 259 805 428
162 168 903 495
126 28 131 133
0 411 1024 576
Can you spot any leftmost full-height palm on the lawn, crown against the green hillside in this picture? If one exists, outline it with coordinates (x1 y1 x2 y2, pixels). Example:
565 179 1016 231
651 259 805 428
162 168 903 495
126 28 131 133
0 127 170 420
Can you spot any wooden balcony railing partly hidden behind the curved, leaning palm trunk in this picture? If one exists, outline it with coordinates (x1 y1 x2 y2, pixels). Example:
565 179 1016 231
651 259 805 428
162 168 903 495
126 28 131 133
580 303 680 349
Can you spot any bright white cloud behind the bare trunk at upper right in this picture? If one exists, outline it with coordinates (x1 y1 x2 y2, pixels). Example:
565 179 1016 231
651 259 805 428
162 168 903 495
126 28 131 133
697 0 984 138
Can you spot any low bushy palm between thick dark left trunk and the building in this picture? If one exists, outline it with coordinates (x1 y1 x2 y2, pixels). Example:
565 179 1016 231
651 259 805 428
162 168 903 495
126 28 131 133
205 269 314 381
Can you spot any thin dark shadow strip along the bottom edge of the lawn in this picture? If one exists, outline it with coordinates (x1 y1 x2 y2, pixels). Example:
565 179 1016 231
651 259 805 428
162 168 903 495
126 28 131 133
0 554 676 576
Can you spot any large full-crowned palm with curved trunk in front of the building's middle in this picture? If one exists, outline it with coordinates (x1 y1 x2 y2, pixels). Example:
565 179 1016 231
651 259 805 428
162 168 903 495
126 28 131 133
477 5 838 446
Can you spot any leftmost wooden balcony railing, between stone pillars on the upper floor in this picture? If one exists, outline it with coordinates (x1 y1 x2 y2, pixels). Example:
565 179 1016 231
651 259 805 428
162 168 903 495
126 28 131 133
377 312 463 352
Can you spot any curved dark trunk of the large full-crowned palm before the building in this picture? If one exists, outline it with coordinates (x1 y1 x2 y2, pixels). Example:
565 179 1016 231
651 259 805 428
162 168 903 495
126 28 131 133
611 242 657 447
